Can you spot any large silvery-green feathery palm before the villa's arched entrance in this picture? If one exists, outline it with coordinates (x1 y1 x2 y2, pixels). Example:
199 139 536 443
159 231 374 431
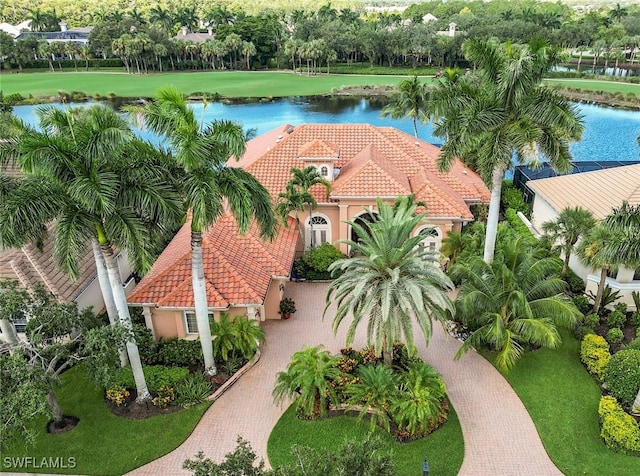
324 197 453 365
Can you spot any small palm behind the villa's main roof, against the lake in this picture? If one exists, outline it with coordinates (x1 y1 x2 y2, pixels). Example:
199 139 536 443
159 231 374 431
380 76 430 138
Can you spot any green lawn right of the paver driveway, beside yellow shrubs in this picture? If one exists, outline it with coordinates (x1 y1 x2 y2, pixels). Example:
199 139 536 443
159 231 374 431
505 332 640 476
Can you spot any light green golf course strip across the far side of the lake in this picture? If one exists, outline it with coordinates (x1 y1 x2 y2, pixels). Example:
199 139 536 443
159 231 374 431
0 71 640 97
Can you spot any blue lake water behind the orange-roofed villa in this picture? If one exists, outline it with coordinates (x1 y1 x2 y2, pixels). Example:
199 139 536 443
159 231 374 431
14 97 640 166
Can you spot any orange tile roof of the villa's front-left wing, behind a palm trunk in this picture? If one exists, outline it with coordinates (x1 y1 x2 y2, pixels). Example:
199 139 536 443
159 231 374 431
128 212 297 308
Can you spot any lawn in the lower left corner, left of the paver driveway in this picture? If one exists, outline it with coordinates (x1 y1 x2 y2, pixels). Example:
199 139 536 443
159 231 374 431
2 367 210 475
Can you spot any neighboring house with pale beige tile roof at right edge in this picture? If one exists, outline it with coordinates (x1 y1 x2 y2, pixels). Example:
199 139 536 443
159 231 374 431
526 164 640 309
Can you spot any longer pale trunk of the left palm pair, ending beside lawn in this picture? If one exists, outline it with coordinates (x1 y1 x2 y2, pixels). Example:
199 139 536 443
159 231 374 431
100 244 151 403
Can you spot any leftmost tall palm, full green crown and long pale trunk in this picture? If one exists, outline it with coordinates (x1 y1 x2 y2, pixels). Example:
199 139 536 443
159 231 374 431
0 106 181 401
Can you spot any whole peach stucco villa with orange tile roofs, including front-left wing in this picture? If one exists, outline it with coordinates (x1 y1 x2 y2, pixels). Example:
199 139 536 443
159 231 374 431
128 124 490 338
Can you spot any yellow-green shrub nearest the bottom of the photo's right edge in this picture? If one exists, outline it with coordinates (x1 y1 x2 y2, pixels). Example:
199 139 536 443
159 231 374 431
598 396 640 455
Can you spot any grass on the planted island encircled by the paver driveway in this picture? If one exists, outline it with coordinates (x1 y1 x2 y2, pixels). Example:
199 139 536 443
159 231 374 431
267 405 464 476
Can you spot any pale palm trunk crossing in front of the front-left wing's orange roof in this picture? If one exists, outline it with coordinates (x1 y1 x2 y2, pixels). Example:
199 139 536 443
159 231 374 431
191 231 218 375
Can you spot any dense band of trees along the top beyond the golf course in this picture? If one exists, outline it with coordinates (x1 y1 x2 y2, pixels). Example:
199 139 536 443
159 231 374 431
0 0 640 73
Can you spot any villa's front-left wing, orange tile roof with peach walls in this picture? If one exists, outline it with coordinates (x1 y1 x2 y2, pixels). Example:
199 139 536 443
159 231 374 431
127 212 298 339
